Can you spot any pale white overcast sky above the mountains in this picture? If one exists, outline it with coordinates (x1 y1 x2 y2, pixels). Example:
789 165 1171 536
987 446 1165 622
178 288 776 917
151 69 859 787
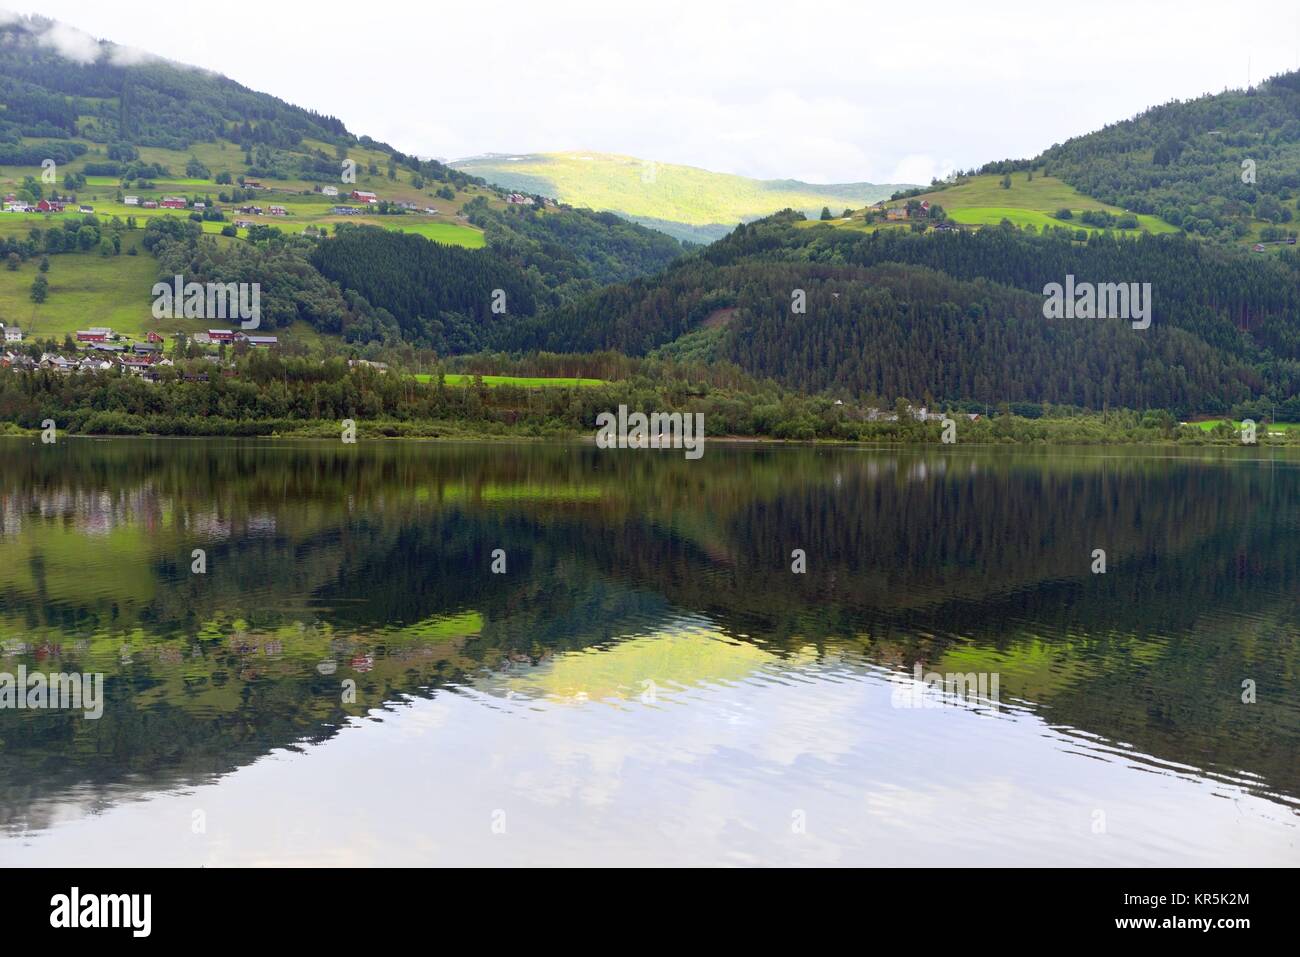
5 0 1300 182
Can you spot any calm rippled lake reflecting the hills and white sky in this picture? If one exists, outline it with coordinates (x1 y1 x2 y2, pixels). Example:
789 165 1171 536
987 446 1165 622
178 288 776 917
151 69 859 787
0 438 1300 866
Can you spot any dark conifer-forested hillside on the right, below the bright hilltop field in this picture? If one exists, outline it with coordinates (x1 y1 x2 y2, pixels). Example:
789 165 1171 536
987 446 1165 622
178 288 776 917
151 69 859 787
503 213 1300 411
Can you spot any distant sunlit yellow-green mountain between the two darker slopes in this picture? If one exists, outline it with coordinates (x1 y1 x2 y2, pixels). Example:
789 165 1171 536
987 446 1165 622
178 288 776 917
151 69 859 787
451 151 910 242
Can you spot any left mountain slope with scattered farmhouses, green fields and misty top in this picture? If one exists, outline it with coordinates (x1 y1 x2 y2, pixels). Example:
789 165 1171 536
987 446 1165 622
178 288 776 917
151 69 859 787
0 17 683 352
